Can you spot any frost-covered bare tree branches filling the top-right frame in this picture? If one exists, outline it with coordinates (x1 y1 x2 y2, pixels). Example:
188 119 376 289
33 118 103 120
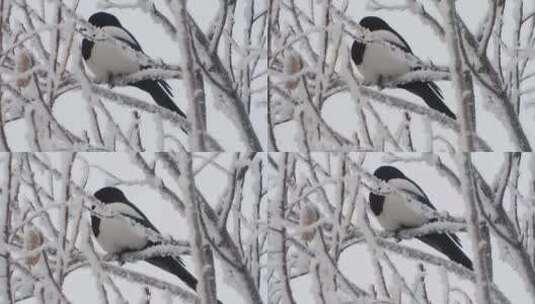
268 0 535 152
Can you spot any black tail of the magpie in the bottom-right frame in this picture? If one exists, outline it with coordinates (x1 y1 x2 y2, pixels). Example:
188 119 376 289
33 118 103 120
418 233 474 270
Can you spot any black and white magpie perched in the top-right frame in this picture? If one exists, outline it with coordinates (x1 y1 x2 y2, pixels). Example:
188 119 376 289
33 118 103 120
351 16 456 119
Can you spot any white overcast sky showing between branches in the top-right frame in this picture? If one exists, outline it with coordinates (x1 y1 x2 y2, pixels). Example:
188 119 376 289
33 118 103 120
276 0 535 151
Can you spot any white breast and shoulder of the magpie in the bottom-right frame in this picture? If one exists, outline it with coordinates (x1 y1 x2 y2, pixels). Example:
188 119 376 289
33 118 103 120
376 178 428 230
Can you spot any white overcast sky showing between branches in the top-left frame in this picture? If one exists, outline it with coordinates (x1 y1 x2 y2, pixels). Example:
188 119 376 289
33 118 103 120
2 1 267 151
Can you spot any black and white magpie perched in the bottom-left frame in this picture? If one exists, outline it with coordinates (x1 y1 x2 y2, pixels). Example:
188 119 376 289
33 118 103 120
91 187 221 303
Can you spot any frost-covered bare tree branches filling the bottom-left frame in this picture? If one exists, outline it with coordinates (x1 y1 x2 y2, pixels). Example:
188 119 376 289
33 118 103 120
0 151 267 303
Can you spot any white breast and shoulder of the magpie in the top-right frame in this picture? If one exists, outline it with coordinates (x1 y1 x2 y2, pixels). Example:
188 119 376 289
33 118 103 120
357 31 411 83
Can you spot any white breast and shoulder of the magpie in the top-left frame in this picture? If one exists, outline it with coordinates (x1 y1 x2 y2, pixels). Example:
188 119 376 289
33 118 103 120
86 26 140 80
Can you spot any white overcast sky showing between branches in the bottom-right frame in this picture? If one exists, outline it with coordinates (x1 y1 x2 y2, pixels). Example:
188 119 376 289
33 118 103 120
284 153 532 303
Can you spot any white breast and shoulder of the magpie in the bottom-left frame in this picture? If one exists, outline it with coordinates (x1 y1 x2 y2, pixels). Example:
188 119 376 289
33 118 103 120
97 203 148 253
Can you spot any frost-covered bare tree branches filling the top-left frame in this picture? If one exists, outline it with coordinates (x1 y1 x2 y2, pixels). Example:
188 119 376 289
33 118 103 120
0 0 266 151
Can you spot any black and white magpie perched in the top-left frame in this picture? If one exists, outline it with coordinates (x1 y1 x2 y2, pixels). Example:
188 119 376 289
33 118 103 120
82 12 186 118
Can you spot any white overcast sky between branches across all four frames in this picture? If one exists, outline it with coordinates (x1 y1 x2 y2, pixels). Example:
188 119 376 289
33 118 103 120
7 0 535 304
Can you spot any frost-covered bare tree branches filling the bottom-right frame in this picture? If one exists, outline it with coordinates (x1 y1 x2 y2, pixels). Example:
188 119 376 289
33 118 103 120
268 153 535 303
